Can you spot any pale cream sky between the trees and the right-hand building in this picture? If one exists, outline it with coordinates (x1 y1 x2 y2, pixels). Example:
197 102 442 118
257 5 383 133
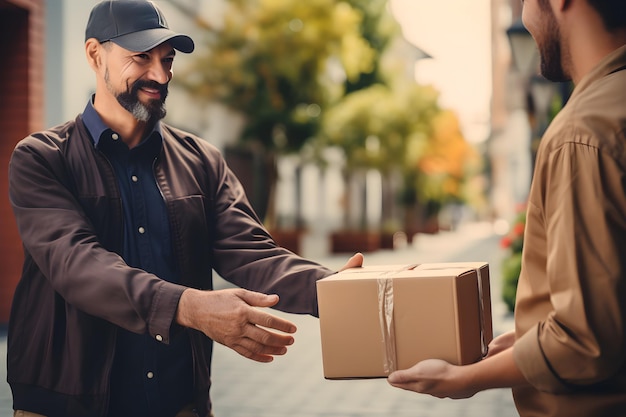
390 0 491 143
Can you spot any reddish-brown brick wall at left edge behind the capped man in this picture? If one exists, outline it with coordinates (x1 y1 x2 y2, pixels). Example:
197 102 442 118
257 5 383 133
0 0 45 323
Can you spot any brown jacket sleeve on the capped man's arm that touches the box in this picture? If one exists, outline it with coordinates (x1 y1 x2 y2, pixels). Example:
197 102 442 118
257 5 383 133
205 150 335 316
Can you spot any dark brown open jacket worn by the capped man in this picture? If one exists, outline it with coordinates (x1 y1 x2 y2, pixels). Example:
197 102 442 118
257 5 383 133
7 116 333 417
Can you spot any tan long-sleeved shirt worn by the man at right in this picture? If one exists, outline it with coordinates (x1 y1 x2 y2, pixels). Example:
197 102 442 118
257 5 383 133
513 46 626 417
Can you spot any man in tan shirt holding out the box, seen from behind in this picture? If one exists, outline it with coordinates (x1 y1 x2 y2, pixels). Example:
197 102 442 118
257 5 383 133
388 0 626 417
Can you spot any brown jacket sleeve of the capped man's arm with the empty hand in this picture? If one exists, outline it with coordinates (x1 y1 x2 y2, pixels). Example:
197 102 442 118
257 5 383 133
9 134 185 343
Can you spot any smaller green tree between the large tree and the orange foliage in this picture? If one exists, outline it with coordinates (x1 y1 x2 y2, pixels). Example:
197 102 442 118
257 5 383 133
323 83 440 226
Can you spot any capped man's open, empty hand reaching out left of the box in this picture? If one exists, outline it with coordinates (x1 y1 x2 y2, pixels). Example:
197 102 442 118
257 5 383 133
176 288 296 362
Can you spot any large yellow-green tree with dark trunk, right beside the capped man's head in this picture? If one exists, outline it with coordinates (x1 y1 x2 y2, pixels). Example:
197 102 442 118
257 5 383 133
172 0 376 226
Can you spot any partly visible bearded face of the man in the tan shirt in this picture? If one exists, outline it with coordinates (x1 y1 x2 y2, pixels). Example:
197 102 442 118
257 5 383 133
522 0 571 82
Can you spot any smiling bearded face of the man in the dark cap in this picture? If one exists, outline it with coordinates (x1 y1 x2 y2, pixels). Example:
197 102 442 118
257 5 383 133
104 43 175 123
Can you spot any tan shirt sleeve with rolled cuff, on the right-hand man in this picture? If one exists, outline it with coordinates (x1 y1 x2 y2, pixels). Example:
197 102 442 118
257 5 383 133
514 143 626 393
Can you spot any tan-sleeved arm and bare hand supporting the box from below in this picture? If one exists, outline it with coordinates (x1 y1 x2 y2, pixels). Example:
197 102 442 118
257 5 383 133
389 145 626 398
